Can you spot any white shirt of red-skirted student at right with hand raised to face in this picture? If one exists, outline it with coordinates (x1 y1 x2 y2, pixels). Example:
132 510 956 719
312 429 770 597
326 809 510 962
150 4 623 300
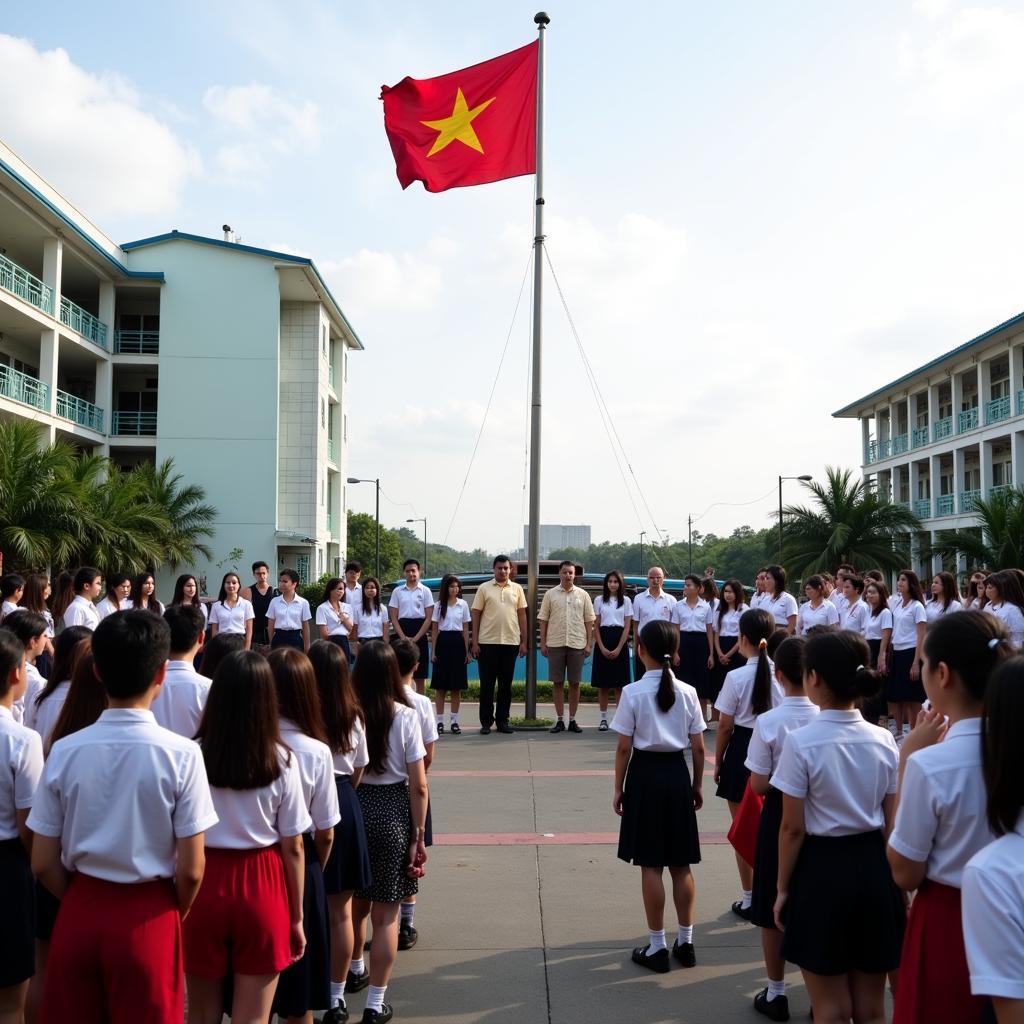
889 718 991 889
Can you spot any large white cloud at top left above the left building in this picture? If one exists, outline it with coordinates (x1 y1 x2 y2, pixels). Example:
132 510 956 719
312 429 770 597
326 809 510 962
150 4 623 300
0 35 201 217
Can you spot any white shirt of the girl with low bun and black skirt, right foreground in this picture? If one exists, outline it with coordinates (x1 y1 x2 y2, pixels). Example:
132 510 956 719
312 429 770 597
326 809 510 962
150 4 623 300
771 711 899 836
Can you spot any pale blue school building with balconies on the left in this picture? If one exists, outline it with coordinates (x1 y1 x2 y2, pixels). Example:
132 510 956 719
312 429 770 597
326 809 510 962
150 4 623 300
0 142 362 600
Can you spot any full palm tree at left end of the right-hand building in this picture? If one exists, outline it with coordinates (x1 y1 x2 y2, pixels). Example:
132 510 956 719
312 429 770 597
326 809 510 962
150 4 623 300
782 466 921 579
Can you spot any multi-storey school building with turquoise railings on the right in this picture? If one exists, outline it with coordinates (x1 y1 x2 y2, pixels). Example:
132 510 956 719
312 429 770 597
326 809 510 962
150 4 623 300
833 313 1024 575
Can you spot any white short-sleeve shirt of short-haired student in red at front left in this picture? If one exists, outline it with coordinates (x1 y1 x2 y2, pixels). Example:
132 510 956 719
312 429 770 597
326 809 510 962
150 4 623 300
29 708 217 884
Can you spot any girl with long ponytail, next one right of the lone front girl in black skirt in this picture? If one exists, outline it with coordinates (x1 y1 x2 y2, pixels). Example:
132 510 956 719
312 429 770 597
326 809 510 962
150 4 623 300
715 607 784 921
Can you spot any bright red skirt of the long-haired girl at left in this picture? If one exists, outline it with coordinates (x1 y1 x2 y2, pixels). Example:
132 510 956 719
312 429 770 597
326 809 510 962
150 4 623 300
183 846 292 978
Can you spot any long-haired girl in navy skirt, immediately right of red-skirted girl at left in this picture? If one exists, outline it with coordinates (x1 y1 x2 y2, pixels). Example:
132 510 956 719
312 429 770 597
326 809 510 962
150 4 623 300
267 647 341 1024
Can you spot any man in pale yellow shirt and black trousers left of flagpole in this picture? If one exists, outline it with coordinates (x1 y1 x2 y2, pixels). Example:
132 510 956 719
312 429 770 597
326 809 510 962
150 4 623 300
470 555 526 736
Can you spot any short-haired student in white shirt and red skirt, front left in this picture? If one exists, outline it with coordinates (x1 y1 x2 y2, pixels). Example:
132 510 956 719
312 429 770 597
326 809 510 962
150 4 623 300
29 611 217 1024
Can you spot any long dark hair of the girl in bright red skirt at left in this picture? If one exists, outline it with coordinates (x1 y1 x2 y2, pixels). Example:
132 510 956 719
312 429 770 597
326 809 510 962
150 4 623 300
196 650 287 790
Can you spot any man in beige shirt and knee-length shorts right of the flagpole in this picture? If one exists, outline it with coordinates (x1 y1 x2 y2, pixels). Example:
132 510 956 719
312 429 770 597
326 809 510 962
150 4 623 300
537 558 596 732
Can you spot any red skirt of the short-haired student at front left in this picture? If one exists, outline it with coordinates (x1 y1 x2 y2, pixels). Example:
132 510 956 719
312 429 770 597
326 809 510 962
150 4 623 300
39 873 185 1024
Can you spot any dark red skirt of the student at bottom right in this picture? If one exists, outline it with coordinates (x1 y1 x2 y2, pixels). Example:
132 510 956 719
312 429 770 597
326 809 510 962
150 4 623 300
893 879 986 1024
